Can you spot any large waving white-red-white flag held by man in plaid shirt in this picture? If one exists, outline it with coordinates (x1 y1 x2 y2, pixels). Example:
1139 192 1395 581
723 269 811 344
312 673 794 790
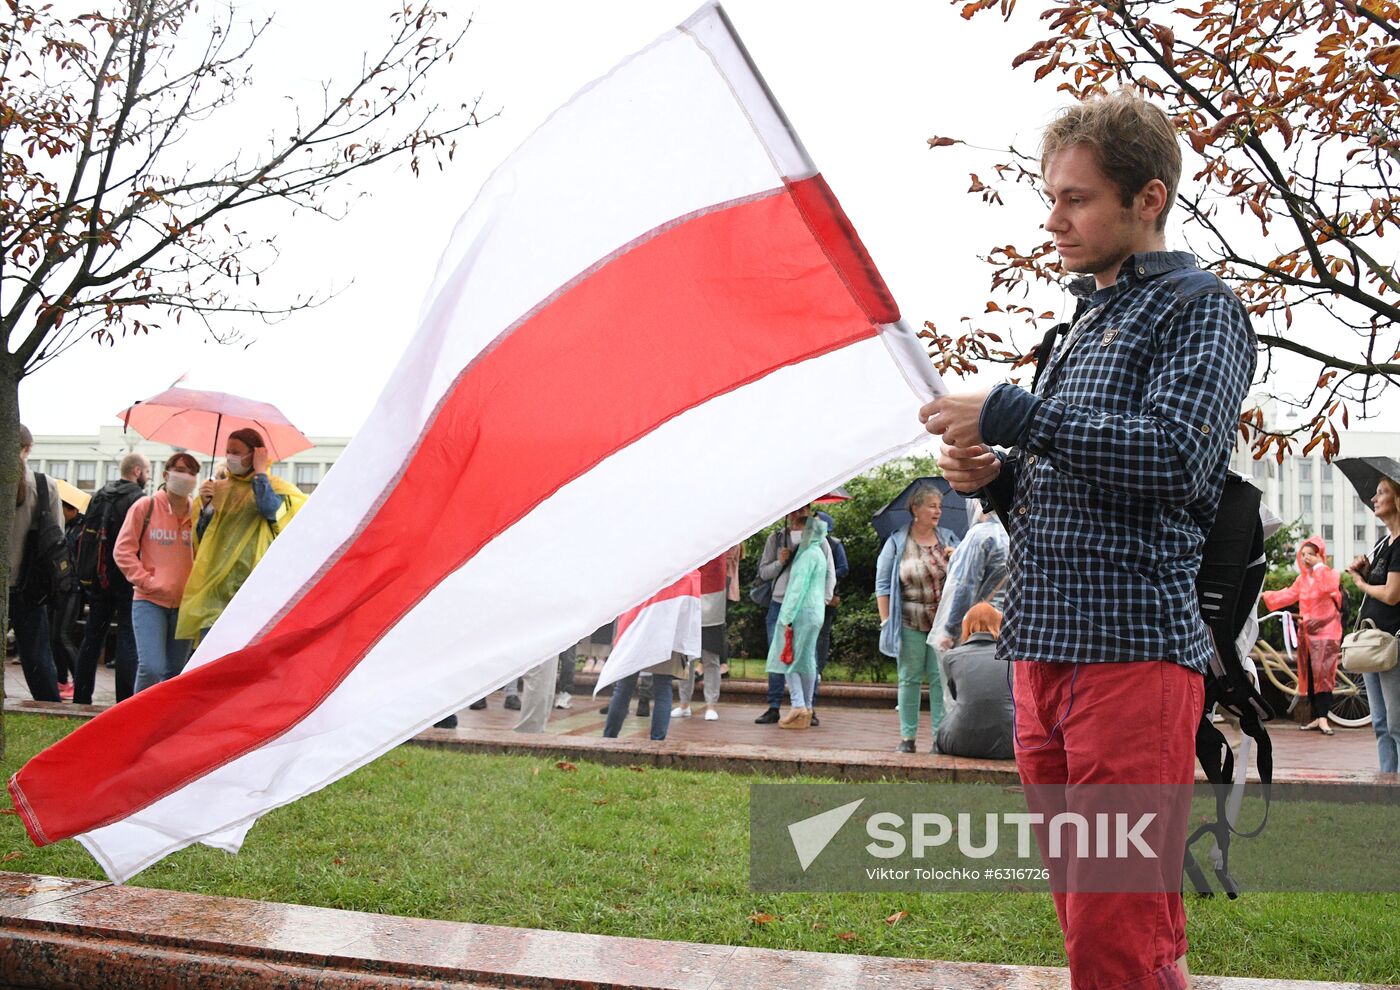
10 4 939 879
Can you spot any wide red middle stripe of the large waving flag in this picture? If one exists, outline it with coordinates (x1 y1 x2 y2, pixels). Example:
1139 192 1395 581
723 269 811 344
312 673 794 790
10 176 885 844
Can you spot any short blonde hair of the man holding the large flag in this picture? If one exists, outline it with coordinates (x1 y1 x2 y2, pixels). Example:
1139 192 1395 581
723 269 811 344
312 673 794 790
1040 90 1182 230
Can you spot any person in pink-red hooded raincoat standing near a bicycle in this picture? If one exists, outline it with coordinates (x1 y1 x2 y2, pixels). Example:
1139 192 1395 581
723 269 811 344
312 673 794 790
1264 536 1341 735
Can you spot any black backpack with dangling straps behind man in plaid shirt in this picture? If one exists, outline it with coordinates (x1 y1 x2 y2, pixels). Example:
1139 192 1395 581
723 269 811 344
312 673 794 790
1184 475 1274 898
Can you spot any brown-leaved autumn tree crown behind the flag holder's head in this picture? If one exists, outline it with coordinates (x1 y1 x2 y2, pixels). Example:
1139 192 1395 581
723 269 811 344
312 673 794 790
925 0 1400 461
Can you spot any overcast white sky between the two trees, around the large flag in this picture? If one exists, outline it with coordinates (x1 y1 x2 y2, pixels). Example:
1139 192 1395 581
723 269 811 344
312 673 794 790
20 0 1394 435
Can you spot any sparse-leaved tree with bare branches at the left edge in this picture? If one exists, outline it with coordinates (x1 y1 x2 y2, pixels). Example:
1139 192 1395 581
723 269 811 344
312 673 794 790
0 0 492 746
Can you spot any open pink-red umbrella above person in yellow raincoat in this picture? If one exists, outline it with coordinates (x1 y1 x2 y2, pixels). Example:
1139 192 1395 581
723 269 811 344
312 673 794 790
118 388 314 461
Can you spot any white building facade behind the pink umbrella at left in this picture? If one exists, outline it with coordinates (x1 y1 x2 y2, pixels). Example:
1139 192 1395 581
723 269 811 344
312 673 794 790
29 426 350 494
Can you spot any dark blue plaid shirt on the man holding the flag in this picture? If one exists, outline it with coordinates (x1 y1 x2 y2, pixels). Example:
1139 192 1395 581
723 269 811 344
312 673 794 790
981 252 1254 671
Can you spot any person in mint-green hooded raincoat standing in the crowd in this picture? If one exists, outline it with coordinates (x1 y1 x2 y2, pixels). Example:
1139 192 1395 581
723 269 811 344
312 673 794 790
767 517 836 728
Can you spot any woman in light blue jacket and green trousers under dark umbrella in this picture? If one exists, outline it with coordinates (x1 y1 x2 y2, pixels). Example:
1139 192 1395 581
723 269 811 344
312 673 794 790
875 482 958 753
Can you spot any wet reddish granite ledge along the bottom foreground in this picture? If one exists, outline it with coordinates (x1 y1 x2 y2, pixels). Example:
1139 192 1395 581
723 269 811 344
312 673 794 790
0 874 1366 990
